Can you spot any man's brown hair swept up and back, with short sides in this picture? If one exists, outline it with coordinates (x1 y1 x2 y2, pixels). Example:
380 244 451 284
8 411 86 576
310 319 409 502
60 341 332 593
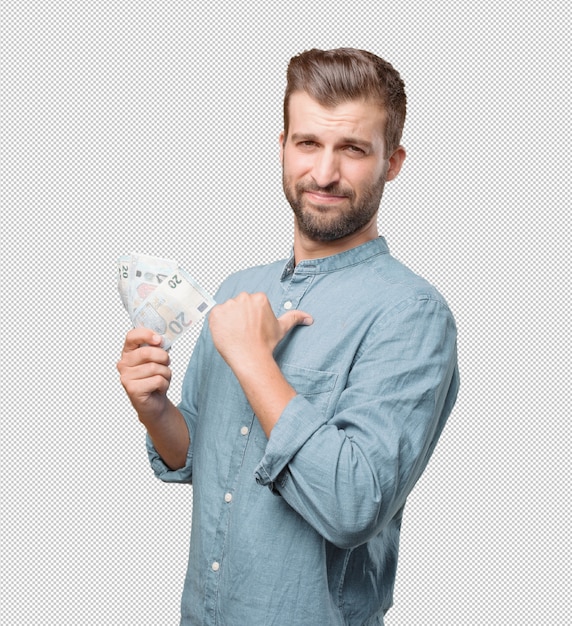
284 48 406 156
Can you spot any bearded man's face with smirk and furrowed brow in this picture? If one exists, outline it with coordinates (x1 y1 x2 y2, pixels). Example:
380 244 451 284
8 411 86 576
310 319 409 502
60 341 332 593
280 91 394 241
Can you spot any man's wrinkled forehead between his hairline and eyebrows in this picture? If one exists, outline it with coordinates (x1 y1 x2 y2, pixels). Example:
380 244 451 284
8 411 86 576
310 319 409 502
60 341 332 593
288 91 386 142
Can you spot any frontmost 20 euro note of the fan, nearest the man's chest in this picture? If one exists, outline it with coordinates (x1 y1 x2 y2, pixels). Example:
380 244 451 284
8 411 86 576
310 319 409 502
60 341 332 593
131 267 216 350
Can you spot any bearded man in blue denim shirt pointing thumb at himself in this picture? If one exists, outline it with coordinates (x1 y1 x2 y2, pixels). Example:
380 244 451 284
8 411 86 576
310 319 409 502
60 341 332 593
118 49 458 626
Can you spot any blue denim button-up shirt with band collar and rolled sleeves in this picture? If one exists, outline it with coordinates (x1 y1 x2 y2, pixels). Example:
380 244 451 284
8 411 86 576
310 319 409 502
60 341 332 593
147 238 458 626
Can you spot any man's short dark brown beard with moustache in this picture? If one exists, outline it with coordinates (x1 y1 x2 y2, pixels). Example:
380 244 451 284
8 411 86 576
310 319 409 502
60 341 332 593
282 171 385 241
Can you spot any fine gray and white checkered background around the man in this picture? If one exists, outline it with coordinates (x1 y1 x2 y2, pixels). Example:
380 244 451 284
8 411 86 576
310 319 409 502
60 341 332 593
0 0 571 626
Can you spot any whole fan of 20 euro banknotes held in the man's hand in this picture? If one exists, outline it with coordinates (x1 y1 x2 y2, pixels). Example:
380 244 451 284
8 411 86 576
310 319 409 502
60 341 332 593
117 254 215 350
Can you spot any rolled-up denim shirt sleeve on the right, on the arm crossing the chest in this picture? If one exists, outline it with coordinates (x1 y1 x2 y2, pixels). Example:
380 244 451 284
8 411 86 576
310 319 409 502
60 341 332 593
255 296 459 548
